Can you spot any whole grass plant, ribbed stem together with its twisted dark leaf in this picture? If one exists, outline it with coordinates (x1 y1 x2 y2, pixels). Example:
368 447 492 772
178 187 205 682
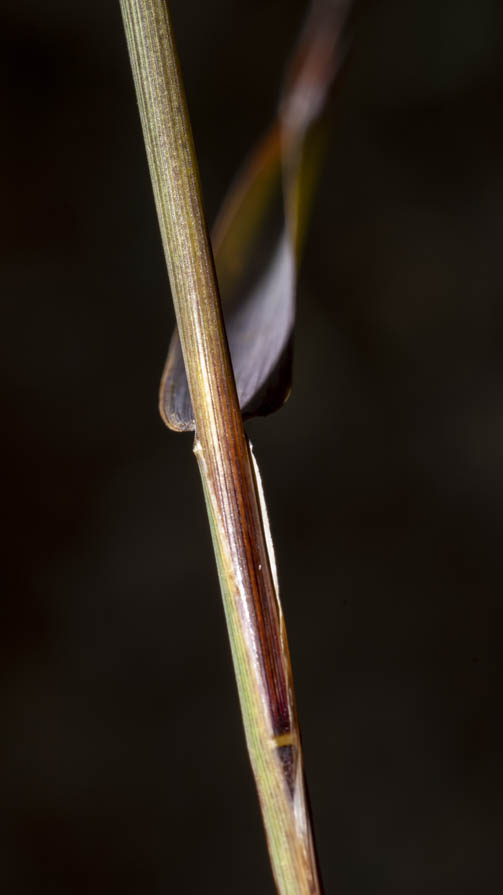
121 0 350 895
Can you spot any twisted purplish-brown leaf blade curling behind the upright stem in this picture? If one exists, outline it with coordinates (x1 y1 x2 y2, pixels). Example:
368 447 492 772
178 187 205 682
160 0 348 431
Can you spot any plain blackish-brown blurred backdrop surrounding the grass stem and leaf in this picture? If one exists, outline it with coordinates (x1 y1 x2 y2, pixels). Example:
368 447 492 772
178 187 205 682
0 0 503 895
